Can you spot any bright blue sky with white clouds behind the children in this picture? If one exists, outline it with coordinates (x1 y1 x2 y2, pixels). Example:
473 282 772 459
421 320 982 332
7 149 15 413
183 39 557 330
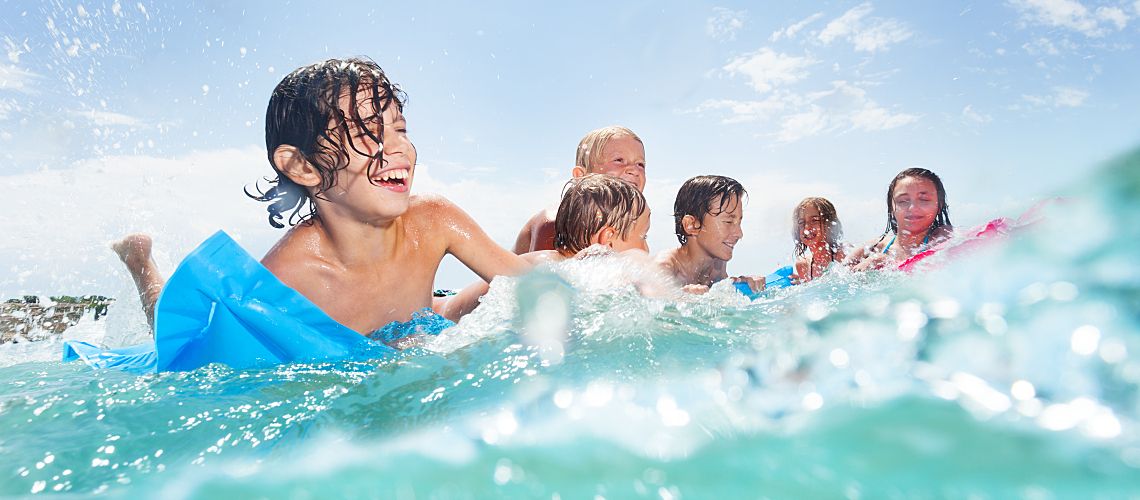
0 0 1140 295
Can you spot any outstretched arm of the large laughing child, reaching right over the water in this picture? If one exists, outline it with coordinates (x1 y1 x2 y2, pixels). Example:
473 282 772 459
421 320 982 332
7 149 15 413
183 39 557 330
426 197 531 281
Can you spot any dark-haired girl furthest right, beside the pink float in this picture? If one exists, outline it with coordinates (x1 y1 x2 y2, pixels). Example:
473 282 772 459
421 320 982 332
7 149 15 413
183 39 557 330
847 167 954 271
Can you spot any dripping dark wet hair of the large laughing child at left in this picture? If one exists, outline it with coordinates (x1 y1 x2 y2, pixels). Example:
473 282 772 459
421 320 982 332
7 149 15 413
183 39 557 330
245 58 407 228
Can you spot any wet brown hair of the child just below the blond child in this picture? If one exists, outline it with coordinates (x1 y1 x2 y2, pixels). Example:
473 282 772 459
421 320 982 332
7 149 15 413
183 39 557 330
554 173 649 256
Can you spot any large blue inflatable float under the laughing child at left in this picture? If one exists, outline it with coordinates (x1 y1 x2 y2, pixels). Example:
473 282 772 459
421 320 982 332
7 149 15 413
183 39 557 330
64 231 454 372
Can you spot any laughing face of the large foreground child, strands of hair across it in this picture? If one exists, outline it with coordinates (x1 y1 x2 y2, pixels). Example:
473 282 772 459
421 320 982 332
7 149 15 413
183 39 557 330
326 95 416 220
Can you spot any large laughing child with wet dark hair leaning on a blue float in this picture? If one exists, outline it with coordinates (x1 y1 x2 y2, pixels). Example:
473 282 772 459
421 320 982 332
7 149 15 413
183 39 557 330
93 58 530 371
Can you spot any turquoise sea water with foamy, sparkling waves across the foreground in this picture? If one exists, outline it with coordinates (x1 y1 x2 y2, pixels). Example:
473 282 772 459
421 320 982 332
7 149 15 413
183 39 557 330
0 154 1140 498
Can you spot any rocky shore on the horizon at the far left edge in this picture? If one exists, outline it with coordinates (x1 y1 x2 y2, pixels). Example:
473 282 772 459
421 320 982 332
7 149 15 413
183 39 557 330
0 295 115 344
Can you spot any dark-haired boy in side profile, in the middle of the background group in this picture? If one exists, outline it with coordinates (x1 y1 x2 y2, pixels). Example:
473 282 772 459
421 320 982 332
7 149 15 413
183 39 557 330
657 175 764 293
